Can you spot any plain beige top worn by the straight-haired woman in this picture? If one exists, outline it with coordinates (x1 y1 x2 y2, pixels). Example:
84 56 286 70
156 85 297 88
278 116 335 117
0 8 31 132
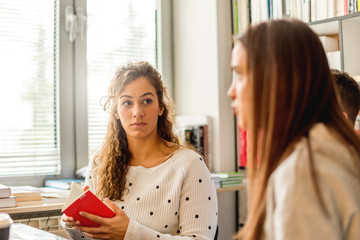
265 124 360 240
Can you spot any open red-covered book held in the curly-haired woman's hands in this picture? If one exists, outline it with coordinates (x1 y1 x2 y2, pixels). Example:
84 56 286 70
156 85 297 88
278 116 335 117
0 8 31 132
61 182 116 227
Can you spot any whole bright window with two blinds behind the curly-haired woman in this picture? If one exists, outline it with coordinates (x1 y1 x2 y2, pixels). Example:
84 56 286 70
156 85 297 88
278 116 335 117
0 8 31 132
0 0 172 182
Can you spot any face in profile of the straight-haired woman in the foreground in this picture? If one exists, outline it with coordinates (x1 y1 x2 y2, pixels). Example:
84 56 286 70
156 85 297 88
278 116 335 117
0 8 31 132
228 43 249 129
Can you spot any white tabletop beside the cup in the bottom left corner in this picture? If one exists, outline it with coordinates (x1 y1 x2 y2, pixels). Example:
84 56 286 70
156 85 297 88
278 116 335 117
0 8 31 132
10 223 66 240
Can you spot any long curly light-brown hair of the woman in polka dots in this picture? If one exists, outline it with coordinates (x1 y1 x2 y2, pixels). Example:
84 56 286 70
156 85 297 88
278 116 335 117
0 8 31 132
93 62 179 200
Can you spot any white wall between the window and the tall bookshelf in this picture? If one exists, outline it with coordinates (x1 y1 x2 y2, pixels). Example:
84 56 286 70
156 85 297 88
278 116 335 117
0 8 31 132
172 0 236 239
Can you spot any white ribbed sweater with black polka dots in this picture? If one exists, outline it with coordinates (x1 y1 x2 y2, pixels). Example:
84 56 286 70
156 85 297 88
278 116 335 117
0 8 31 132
63 149 218 240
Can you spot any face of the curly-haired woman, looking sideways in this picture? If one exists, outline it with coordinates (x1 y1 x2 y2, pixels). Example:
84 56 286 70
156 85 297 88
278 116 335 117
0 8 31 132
115 77 164 141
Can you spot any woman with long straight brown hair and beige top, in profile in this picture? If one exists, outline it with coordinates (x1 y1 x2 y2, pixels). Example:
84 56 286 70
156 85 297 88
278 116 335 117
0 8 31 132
228 20 360 240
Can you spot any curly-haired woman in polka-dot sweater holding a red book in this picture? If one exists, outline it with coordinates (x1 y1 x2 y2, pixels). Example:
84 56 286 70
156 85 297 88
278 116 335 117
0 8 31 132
62 62 217 239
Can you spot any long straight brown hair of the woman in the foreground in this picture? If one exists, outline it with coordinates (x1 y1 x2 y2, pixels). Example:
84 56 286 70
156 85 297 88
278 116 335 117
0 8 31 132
235 20 360 239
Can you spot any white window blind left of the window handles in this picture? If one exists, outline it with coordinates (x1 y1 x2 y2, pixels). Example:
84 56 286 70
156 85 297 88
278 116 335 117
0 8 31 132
0 0 60 177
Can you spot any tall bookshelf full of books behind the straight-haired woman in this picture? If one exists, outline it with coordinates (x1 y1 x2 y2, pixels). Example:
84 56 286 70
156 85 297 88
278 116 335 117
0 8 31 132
231 0 360 232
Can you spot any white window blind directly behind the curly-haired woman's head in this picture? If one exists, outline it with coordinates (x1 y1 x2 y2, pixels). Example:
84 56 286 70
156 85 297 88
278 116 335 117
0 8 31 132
87 0 161 156
